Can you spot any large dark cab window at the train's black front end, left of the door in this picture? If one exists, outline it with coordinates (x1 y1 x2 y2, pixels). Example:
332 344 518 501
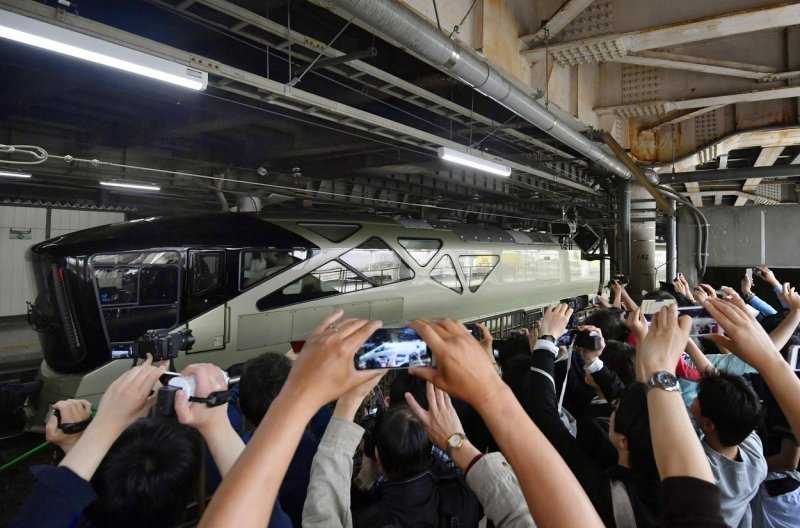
92 251 181 343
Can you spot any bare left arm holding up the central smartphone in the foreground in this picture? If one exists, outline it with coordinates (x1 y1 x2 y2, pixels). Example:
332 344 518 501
199 311 386 528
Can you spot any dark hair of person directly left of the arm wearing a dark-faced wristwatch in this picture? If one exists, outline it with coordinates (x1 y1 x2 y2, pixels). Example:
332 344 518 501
614 382 658 480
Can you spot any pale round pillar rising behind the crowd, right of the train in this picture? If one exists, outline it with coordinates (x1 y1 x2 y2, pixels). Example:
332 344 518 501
628 183 656 302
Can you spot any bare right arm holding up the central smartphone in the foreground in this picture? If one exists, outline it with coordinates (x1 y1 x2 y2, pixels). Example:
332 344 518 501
410 319 602 527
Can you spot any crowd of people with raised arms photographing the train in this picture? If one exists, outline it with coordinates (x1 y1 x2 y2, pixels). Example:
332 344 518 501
7 267 800 528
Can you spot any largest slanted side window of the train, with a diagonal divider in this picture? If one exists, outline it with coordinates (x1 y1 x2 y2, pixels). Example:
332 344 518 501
256 238 414 310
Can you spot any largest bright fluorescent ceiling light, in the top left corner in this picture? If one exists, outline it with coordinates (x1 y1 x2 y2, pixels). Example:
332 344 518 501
0 9 208 90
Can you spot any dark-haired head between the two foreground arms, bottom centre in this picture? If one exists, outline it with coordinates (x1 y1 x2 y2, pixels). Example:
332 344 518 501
375 403 433 481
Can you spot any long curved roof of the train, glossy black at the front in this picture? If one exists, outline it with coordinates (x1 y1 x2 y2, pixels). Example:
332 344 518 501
26 213 555 256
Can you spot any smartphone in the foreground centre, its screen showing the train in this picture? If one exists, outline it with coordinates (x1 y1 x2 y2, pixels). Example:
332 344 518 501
354 326 434 370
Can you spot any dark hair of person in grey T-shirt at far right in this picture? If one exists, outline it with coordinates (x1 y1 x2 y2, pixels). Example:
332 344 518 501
697 371 761 447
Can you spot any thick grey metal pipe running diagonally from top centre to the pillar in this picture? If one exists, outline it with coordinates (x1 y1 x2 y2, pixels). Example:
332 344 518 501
324 0 631 180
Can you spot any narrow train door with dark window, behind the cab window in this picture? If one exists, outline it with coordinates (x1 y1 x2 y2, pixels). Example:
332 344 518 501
186 250 228 352
